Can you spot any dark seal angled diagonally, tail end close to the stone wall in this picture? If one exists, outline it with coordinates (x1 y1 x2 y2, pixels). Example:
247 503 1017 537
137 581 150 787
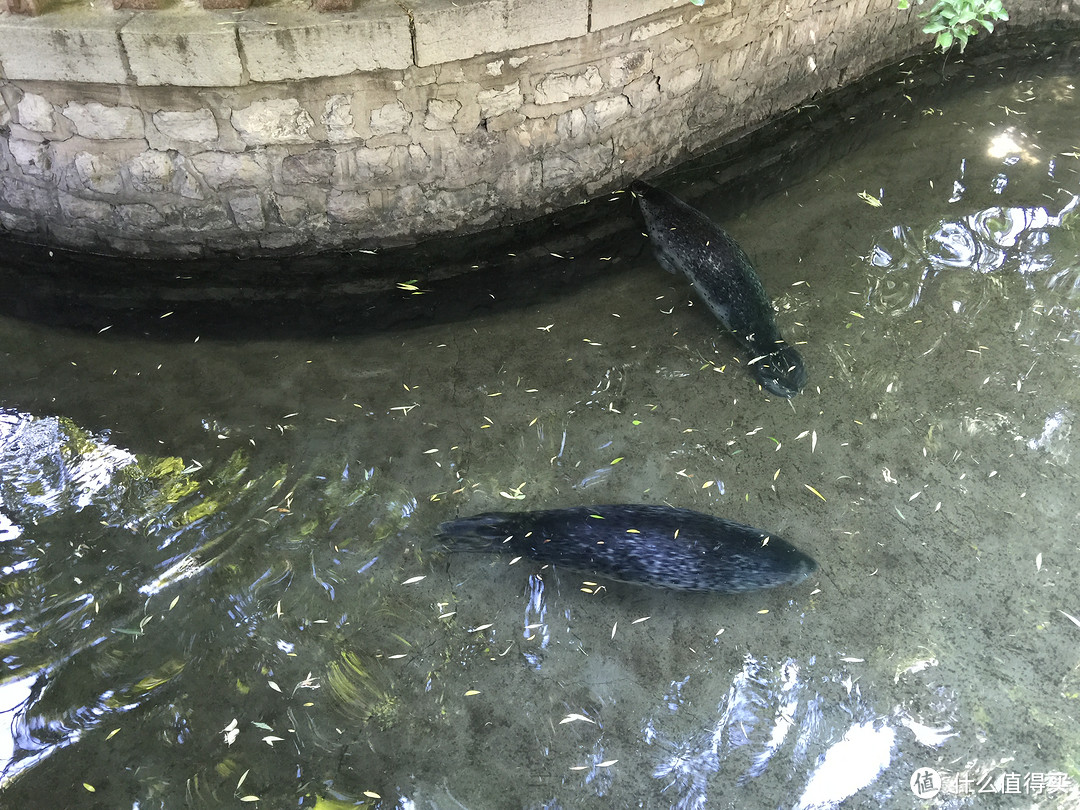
630 180 807 399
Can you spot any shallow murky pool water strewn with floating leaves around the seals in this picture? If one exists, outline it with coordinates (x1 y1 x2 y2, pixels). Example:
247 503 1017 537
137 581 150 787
0 36 1080 810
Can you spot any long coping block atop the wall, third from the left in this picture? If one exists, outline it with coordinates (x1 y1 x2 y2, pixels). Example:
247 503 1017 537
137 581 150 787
240 0 413 82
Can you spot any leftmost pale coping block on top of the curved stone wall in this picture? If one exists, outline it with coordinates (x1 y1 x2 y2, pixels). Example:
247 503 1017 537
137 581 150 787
0 8 132 84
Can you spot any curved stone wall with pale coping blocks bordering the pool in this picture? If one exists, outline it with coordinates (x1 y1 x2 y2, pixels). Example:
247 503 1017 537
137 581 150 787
0 0 1072 256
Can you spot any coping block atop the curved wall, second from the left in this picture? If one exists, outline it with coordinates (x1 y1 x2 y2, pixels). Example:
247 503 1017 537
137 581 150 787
120 10 243 87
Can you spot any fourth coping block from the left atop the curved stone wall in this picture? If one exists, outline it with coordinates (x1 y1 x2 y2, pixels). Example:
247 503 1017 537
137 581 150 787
410 0 589 67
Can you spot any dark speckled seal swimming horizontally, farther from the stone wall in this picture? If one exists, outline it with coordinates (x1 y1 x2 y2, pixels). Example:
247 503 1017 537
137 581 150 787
437 503 818 593
